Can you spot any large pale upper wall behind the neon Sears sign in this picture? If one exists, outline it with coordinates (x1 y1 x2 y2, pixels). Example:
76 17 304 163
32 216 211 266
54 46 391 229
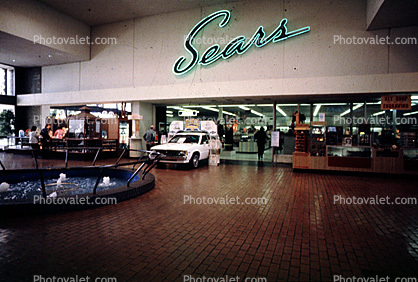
22 0 418 104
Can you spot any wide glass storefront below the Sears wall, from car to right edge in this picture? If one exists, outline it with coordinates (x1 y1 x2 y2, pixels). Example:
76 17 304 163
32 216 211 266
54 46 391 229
162 95 418 165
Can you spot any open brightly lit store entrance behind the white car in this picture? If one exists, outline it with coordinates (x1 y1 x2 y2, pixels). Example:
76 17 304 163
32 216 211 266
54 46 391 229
166 104 277 164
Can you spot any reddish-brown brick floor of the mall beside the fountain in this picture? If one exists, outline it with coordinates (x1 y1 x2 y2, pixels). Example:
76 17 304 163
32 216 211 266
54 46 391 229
0 154 418 281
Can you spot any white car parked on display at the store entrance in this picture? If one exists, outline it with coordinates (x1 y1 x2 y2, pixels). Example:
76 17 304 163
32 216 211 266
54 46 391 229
151 131 210 168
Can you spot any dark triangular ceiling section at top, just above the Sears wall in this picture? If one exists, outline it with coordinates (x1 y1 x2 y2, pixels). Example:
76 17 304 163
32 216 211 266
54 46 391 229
39 0 240 26
